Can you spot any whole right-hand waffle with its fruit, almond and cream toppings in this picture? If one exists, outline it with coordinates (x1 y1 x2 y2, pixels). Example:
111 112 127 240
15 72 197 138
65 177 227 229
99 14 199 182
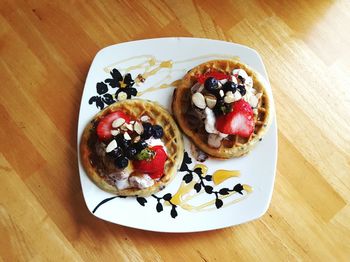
172 60 271 158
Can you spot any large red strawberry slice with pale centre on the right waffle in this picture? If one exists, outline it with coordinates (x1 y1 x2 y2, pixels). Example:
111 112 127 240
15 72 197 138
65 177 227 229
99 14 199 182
216 99 254 137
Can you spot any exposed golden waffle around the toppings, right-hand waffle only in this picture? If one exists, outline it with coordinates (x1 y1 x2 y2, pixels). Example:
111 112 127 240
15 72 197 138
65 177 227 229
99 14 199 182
172 60 271 158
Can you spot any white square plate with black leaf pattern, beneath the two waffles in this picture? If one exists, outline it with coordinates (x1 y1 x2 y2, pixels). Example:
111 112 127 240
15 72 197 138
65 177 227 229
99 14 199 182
78 38 277 232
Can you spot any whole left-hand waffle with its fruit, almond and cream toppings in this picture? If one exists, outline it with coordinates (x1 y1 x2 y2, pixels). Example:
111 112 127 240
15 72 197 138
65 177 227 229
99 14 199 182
80 99 184 196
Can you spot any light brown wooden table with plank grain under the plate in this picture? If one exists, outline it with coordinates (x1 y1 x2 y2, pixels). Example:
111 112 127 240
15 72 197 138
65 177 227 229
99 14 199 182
0 0 350 261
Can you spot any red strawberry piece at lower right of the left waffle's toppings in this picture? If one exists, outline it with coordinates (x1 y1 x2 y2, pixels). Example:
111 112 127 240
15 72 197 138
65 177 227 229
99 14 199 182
133 146 168 179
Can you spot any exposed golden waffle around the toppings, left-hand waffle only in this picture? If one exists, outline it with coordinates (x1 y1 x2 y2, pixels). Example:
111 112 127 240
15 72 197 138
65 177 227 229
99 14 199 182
80 99 184 196
